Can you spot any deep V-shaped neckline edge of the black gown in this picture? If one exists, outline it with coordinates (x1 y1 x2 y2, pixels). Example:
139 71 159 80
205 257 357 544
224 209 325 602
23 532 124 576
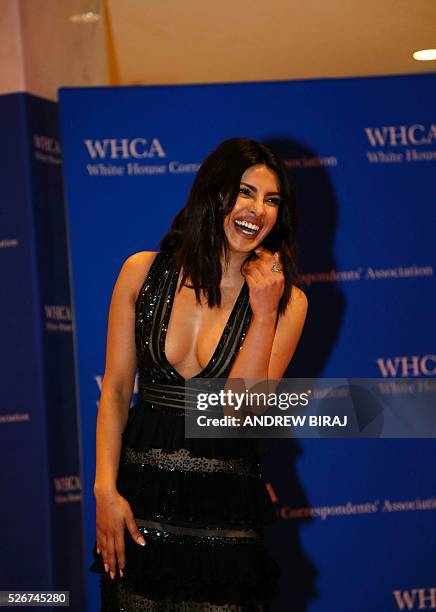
160 264 247 382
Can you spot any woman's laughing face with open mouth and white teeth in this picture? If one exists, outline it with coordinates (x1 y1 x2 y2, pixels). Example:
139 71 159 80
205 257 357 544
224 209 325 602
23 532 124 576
224 164 280 253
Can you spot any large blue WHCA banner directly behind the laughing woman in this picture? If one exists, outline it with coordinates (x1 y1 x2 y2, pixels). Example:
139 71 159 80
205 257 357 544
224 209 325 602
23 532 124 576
60 74 436 612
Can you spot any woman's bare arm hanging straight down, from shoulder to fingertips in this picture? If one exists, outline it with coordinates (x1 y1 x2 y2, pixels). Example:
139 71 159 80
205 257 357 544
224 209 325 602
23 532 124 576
94 252 156 578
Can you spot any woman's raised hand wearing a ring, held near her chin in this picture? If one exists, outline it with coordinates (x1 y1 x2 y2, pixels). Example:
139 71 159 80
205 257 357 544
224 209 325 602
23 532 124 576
243 247 285 318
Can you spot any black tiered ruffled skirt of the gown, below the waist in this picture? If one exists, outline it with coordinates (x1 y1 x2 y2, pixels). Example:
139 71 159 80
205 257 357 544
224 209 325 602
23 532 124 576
90 401 279 612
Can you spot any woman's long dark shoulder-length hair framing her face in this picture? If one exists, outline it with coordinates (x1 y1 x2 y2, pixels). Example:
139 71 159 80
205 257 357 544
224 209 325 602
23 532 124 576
160 138 299 315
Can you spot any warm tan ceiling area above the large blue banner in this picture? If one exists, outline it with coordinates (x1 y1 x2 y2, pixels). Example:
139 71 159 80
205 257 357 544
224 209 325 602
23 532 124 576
105 0 436 85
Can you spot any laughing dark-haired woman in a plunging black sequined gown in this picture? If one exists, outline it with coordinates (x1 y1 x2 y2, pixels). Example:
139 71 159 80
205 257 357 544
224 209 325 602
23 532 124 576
91 138 307 612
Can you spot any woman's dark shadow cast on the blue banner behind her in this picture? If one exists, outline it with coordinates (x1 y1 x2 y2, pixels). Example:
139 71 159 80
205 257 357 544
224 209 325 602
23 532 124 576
263 136 344 612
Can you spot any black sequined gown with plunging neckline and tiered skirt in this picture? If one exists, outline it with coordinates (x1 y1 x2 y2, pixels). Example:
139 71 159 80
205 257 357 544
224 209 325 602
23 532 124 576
90 252 279 612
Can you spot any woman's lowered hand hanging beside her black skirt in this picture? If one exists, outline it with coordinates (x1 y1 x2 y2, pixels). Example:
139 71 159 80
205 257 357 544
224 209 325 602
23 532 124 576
95 490 145 578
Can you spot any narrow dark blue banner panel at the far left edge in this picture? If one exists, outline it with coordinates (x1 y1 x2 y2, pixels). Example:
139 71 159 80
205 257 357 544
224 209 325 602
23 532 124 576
0 93 85 612
